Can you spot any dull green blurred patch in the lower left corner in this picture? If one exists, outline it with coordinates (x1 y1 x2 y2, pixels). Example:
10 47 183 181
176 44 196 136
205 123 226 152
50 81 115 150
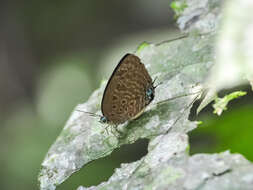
0 102 60 189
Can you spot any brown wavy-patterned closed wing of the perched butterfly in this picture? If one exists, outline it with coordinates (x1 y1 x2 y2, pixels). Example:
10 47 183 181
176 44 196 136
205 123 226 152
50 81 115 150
101 54 153 124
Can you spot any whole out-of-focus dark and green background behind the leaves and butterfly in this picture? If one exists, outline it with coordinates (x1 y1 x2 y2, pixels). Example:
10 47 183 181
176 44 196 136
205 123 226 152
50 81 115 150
0 0 253 190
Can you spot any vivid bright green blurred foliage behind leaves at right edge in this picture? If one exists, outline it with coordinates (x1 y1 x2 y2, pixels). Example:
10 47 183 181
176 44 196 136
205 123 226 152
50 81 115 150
190 92 253 161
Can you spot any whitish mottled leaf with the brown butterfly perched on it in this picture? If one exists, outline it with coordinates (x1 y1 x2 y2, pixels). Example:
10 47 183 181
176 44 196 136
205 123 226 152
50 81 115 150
39 34 213 190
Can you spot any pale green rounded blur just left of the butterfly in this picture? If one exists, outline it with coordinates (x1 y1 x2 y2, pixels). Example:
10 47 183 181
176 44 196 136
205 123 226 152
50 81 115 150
37 56 96 125
